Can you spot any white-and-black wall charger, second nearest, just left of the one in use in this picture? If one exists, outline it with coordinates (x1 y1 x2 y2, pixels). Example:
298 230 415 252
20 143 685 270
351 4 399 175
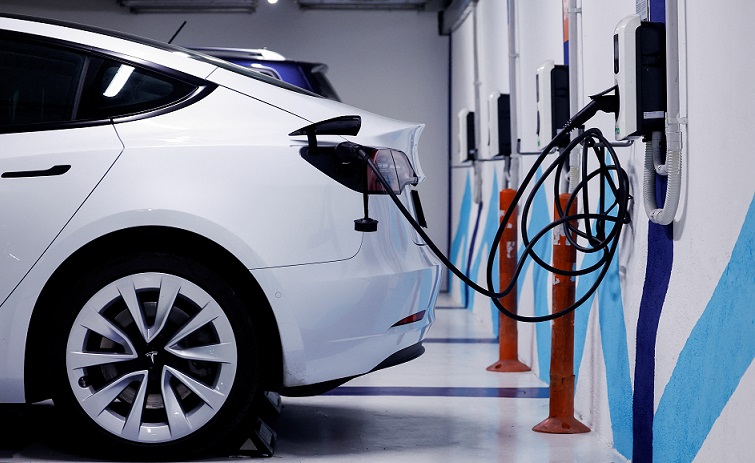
535 60 570 148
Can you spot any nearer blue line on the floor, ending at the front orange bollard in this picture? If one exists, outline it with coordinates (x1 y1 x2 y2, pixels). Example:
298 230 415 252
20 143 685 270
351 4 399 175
324 386 549 399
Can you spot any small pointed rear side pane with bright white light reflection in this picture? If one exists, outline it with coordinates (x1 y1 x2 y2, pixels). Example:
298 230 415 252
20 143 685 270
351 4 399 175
76 56 197 120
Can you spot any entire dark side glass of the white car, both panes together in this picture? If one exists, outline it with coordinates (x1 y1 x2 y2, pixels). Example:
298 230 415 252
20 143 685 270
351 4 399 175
0 33 207 132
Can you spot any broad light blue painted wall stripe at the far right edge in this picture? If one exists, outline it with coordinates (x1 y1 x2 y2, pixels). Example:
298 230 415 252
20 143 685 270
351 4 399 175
653 196 755 462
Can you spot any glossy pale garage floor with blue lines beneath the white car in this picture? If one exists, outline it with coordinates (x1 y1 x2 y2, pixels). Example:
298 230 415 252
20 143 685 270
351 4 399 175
0 302 626 463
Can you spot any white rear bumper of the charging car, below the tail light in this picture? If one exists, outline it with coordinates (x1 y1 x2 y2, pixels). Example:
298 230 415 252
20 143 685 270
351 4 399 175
254 229 441 388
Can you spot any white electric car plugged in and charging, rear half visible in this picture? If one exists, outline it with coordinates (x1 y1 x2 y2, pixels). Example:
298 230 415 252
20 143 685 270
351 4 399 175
0 15 440 458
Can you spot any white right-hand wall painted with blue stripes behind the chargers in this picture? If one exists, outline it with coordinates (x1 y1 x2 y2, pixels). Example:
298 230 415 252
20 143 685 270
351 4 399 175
449 0 755 462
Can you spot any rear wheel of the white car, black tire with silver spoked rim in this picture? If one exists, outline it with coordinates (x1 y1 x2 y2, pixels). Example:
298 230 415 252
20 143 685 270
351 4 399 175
51 253 259 459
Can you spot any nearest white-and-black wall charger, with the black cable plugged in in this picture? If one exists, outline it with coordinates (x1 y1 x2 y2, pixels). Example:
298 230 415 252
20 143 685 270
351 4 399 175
613 15 666 140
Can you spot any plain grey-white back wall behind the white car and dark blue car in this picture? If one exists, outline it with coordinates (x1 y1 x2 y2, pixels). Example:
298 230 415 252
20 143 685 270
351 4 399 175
0 0 448 280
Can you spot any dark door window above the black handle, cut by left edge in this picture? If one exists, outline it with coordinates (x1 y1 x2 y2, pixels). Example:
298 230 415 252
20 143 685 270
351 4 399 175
0 38 86 128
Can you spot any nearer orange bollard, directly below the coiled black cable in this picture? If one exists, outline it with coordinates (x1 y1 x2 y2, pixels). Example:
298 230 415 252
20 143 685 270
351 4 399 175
532 193 590 434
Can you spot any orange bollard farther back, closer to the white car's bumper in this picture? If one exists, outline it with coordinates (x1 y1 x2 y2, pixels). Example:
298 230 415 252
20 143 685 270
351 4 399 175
487 188 530 372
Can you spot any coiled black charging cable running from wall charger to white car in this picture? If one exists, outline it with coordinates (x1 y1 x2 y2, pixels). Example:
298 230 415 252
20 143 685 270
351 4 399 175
353 87 631 323
